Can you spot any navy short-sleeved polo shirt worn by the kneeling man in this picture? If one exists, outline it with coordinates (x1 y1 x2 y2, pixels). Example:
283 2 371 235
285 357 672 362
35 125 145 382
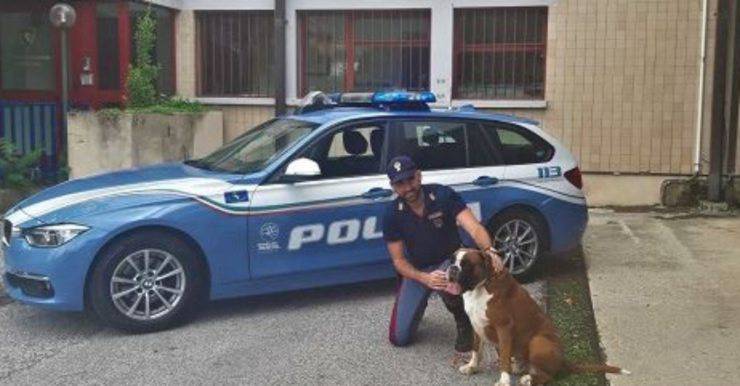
383 184 466 268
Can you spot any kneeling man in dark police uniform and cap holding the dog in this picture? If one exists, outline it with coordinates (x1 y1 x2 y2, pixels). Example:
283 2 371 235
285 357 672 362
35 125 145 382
383 156 503 353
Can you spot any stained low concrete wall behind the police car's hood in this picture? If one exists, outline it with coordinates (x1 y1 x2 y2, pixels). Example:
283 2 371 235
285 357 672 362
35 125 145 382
67 111 224 178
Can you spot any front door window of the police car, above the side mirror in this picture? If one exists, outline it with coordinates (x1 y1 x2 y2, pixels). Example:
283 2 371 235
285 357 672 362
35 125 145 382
303 122 386 179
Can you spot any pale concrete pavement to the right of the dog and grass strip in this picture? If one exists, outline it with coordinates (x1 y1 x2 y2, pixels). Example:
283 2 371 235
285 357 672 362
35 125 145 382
584 211 740 385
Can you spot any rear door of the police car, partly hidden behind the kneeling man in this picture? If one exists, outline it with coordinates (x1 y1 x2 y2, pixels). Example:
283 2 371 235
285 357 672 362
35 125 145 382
391 118 505 231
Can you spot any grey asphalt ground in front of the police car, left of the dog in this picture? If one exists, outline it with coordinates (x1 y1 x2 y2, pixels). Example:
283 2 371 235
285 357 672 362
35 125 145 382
0 246 544 385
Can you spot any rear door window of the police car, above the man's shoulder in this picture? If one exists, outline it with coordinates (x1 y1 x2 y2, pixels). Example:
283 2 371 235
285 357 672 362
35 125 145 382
395 121 468 170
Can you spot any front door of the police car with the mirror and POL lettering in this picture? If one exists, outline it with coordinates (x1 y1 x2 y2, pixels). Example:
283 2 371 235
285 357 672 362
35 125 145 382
249 120 392 278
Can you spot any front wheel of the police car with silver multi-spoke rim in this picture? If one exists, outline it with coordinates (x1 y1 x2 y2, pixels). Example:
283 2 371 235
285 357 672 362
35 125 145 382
88 231 207 332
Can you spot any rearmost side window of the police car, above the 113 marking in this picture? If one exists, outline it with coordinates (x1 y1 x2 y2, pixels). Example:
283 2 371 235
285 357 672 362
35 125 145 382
485 124 555 165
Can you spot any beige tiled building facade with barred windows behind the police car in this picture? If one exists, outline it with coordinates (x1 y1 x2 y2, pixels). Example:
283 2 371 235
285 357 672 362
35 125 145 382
0 0 740 205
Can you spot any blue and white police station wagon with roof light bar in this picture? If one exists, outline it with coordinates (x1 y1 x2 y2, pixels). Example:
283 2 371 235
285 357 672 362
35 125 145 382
2 92 587 331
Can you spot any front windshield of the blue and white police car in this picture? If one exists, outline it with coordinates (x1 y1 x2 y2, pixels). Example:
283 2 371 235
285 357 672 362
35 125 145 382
186 119 319 174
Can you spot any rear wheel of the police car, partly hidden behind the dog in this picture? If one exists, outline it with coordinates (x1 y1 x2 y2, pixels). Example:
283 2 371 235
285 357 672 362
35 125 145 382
488 210 546 279
